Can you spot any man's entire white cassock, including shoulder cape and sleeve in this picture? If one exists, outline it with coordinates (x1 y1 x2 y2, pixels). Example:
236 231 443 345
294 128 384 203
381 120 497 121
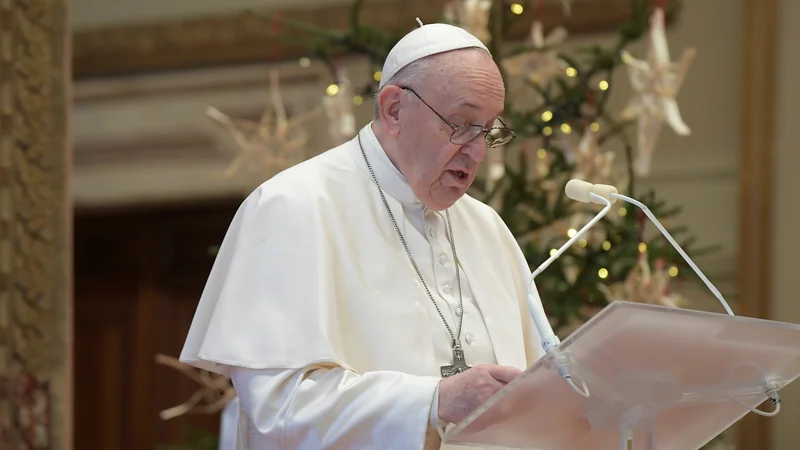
180 121 543 450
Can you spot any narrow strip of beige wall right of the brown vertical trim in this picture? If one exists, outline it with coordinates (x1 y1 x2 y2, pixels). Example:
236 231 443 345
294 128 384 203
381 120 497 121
772 0 800 450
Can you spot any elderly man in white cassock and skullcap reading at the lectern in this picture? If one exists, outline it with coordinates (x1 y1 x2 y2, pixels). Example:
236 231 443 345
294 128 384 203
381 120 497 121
181 24 541 450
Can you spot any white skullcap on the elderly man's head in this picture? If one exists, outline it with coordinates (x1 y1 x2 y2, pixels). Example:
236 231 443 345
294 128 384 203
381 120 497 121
378 19 489 88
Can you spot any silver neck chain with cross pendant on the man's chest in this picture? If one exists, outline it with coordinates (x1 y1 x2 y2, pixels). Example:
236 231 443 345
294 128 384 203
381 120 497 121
358 133 470 377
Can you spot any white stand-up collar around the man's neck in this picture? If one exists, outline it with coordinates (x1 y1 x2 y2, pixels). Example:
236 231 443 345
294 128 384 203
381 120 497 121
356 122 425 209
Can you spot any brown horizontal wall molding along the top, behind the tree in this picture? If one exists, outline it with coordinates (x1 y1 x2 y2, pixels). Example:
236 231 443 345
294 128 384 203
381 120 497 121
73 0 673 79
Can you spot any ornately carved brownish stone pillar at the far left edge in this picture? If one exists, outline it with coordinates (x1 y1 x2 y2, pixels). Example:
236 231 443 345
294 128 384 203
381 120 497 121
0 0 72 450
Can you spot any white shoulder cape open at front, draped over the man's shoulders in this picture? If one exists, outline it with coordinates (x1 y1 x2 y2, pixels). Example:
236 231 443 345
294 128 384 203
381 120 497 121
180 129 542 376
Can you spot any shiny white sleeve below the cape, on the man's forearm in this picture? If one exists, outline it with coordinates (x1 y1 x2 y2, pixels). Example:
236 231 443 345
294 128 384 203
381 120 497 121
230 367 440 450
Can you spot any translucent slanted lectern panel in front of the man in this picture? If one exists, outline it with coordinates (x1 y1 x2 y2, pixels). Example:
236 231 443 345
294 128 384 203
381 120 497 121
444 302 800 450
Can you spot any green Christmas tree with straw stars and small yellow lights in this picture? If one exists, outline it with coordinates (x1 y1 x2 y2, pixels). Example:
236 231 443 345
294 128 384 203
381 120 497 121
159 0 736 448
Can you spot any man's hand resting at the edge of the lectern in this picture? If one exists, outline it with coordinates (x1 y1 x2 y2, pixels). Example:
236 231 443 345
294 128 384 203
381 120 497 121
439 364 521 423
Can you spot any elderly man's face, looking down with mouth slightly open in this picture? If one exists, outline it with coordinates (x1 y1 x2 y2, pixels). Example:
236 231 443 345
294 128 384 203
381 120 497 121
396 51 505 211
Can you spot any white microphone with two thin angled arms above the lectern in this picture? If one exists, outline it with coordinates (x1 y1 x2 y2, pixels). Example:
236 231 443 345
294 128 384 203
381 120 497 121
528 179 734 397
